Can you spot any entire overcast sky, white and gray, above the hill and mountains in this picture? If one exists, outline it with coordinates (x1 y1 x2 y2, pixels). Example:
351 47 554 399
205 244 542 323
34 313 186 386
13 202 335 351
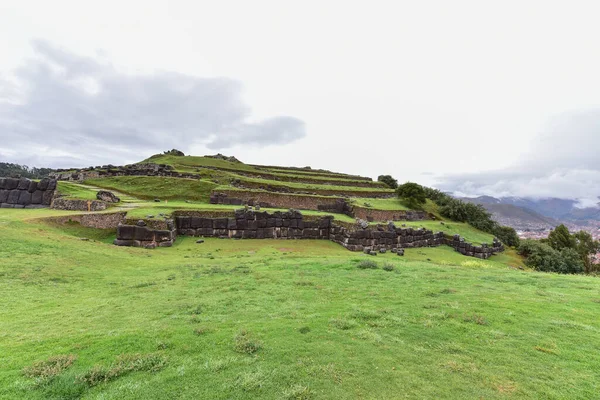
0 0 600 204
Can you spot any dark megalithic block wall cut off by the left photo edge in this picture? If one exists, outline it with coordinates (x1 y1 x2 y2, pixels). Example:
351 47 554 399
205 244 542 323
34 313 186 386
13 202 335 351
0 178 56 208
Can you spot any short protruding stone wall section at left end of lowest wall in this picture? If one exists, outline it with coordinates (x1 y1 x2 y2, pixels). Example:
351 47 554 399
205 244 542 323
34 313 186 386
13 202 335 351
114 220 177 249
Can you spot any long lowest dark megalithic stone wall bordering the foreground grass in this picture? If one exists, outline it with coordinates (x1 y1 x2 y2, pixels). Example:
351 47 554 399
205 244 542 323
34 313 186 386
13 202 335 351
115 210 504 259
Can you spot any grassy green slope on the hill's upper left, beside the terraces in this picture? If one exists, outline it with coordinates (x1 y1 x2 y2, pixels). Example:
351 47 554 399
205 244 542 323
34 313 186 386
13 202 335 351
85 176 217 202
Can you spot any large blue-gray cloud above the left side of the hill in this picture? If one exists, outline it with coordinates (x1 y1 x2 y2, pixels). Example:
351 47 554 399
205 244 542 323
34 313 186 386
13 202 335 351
0 41 305 166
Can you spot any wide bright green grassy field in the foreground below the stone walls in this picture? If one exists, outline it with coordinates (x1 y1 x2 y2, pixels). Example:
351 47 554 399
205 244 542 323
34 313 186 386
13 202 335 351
0 209 600 399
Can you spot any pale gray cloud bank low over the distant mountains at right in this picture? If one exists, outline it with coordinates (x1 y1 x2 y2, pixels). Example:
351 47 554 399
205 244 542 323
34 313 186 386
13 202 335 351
436 109 600 207
